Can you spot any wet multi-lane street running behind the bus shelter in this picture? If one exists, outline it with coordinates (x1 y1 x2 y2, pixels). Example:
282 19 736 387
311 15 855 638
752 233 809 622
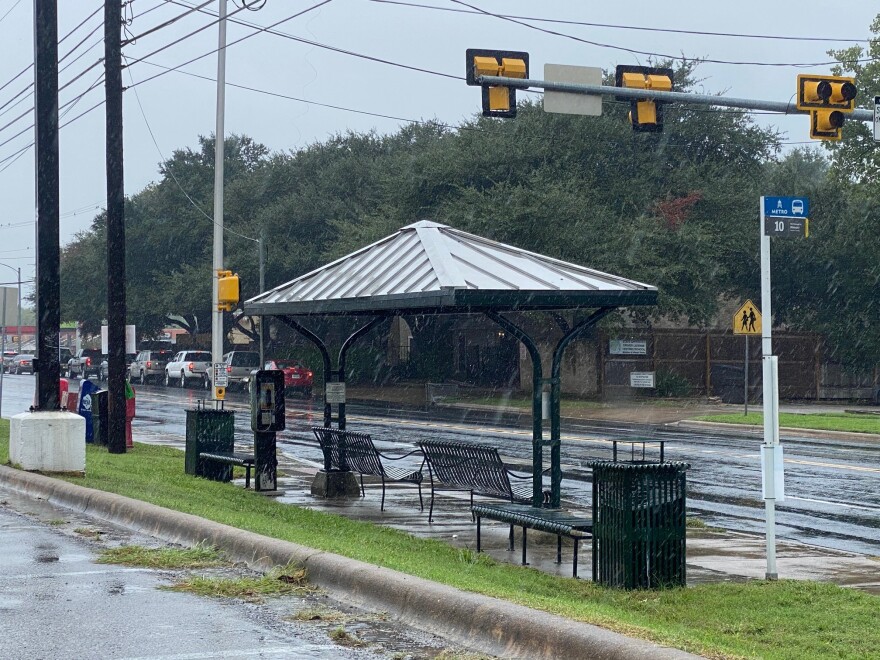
3 376 880 555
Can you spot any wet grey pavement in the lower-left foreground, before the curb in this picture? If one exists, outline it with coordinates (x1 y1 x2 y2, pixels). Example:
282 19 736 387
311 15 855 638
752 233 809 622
0 488 457 660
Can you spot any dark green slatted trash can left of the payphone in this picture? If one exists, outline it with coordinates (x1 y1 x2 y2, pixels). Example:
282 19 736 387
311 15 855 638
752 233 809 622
184 407 235 481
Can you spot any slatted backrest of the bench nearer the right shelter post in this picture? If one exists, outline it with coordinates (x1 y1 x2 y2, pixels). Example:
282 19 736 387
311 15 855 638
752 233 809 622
419 441 513 500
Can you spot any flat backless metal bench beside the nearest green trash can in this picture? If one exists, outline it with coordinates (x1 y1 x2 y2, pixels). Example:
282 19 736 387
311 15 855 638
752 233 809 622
471 503 593 578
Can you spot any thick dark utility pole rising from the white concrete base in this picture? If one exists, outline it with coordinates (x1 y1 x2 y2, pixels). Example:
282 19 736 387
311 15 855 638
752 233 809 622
34 0 61 412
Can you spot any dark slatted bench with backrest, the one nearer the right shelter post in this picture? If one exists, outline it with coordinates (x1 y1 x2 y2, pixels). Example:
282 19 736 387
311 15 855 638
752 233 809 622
419 440 550 522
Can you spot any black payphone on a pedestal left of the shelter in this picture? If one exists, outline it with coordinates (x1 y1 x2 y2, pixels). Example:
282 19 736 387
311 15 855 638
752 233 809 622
251 369 284 491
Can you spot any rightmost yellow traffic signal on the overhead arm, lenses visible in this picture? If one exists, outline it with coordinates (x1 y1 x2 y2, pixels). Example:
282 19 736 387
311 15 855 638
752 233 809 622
797 73 858 140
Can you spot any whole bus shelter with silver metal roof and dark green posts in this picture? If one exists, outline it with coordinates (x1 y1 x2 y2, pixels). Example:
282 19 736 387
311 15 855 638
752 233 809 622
244 220 657 507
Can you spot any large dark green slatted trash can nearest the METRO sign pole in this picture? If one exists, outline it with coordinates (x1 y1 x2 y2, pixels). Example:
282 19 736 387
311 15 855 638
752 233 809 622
589 461 690 589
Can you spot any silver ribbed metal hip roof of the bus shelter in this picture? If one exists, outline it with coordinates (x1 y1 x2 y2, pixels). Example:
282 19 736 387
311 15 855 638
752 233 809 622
244 220 657 316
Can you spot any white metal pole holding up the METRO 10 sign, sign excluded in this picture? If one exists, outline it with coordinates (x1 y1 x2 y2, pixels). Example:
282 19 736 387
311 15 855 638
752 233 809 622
759 197 779 580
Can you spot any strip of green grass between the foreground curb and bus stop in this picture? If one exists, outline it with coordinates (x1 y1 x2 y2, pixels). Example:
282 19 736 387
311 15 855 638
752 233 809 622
0 430 880 659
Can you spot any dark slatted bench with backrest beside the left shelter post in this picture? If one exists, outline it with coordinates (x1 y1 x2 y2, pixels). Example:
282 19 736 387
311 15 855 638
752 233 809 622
312 426 425 511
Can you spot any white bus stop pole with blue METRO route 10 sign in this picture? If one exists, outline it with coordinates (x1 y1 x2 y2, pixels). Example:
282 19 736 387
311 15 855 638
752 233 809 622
759 197 810 580
